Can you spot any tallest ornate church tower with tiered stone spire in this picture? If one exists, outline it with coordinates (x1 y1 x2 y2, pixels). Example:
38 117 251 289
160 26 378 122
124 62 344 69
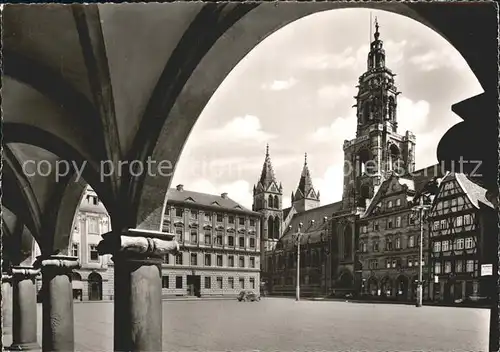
342 19 416 209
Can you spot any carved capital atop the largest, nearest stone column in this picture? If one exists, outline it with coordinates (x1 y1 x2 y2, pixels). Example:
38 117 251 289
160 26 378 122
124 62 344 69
97 229 179 258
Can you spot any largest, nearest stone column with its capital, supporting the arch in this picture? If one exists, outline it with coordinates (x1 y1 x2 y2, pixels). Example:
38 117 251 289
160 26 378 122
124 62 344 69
98 229 179 351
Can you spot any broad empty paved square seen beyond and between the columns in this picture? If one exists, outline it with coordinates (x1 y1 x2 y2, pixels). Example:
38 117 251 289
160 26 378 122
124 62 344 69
4 298 489 352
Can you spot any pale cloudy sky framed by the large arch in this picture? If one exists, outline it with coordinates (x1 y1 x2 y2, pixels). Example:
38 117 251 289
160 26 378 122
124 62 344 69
172 9 483 209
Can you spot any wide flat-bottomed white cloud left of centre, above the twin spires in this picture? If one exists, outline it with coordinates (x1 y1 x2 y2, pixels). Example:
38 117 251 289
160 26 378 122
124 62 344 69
193 115 276 145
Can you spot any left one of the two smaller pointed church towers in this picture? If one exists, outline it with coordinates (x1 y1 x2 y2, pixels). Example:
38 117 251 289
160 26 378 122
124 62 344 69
252 145 283 252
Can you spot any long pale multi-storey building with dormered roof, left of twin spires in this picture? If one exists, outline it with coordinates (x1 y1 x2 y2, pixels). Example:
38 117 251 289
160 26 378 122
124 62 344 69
162 185 261 297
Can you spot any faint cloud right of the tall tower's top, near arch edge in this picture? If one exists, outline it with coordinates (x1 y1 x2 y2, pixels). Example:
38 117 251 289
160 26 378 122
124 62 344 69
409 47 469 72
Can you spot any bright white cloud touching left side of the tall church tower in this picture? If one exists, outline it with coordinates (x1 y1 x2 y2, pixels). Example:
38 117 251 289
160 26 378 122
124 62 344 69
309 116 356 146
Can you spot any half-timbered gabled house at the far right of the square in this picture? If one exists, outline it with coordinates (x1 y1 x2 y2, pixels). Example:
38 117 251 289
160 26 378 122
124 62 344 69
429 173 498 303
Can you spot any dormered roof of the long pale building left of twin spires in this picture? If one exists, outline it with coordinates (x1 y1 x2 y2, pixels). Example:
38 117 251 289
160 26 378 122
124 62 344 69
167 188 261 216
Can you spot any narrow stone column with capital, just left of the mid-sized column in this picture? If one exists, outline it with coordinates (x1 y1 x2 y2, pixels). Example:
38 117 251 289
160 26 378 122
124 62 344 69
7 266 40 351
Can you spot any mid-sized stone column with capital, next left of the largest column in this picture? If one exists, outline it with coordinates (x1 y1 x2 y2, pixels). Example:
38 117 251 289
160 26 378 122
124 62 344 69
35 255 80 351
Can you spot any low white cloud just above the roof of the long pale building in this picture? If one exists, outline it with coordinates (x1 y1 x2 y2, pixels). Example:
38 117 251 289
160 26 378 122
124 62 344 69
188 178 253 209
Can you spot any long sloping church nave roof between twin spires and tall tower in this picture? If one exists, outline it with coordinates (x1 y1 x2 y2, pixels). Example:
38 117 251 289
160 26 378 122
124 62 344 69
280 201 342 247
